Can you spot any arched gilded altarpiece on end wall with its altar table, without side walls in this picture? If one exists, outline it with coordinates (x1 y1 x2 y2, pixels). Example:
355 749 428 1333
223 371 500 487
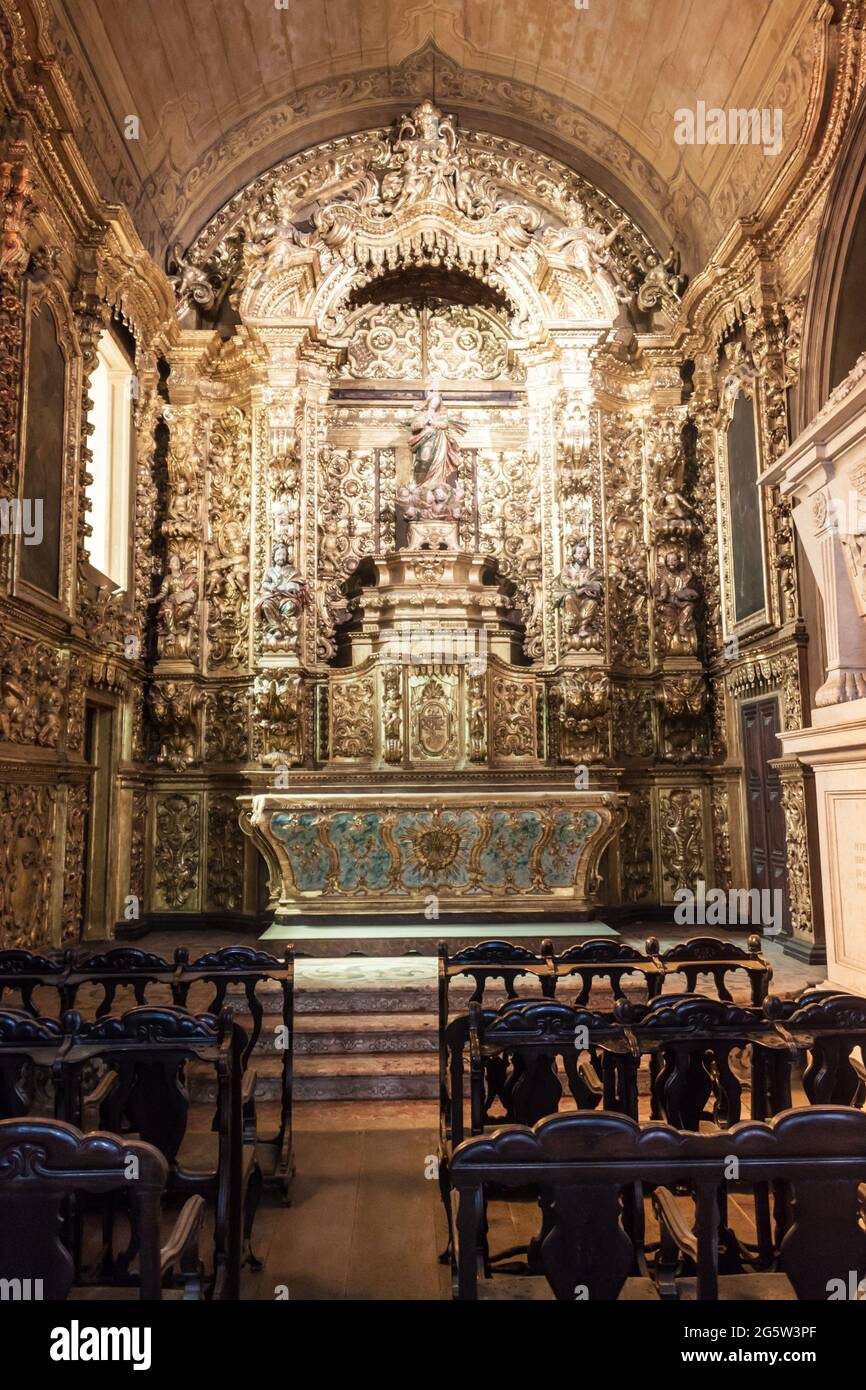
140 101 719 916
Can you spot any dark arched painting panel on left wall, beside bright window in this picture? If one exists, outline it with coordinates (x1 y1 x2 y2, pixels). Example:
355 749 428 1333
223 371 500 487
19 309 65 598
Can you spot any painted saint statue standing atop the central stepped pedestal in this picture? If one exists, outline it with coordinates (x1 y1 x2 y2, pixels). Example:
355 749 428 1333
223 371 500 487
398 391 466 549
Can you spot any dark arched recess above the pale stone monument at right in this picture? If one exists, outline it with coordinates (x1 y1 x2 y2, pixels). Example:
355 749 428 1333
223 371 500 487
792 93 866 434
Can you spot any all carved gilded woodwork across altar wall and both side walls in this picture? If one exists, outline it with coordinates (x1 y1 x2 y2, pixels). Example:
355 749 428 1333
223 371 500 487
0 4 862 945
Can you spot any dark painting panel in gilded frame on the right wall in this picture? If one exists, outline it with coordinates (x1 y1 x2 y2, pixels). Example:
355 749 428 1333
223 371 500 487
727 392 766 623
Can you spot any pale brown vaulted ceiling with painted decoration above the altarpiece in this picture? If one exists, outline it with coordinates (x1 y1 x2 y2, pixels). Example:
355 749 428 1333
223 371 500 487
51 0 816 267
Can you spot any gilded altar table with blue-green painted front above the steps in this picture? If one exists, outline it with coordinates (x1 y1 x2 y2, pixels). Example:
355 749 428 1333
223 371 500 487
240 788 624 920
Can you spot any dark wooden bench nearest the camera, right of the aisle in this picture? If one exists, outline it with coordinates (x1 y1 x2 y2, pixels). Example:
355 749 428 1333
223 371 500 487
450 1106 866 1304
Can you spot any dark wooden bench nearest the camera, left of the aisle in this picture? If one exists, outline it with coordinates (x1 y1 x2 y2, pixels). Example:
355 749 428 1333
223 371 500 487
0 1119 204 1300
